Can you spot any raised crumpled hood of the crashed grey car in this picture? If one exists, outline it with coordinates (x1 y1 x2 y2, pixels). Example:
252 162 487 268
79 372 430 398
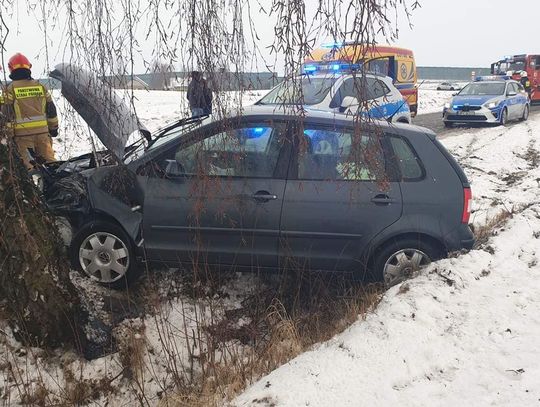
49 63 150 160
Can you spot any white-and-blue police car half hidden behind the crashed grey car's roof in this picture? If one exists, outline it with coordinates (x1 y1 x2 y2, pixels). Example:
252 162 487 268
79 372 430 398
256 64 411 123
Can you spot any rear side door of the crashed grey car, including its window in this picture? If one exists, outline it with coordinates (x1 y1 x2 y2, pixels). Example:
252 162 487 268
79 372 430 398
279 123 402 270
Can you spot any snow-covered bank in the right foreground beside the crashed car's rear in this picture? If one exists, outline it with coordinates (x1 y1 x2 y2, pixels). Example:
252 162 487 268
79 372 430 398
233 118 540 407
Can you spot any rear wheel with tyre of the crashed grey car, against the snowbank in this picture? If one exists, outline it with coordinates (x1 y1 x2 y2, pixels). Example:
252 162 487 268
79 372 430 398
371 238 443 287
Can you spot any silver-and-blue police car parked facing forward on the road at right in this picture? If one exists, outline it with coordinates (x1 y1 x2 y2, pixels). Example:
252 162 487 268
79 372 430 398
443 76 530 127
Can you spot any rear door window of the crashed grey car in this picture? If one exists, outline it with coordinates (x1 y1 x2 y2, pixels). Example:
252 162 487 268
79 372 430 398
298 128 385 181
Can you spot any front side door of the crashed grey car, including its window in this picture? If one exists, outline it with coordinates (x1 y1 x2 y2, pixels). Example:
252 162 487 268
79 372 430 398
143 121 290 267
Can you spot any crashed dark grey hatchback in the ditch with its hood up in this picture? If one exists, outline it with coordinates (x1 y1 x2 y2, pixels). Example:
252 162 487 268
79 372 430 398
45 66 473 286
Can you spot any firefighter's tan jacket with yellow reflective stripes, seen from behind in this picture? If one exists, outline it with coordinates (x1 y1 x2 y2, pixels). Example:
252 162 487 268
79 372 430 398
3 79 58 136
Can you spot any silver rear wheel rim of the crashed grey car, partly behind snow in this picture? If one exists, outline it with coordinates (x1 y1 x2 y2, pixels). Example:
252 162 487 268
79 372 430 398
383 249 431 287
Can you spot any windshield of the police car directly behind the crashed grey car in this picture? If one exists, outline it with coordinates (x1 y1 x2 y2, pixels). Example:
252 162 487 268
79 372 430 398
259 76 337 105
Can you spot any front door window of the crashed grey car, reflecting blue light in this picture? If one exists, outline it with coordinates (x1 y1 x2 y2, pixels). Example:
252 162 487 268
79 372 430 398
173 124 280 178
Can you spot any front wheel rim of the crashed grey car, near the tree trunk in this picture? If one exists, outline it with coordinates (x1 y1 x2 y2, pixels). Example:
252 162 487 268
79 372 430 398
79 232 129 283
